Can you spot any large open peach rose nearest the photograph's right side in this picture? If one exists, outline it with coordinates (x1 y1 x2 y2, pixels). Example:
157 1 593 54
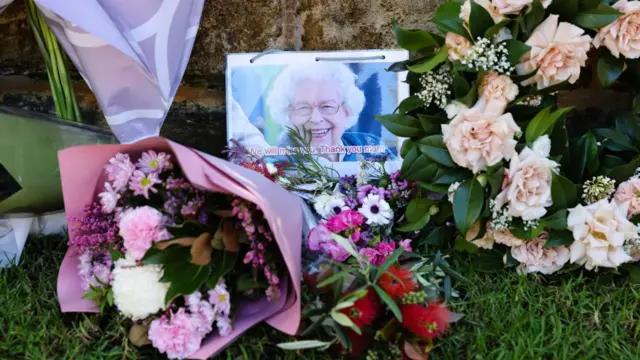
442 102 520 173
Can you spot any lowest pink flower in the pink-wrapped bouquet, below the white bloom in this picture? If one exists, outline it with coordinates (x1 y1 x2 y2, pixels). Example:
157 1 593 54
149 308 204 359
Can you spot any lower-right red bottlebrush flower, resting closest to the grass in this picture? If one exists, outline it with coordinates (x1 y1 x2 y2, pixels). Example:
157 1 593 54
400 302 450 340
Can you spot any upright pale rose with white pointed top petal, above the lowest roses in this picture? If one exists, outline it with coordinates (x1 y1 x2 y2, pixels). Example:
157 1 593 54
496 135 558 220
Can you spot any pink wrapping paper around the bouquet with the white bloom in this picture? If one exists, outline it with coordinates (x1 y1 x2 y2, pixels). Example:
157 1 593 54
58 137 302 359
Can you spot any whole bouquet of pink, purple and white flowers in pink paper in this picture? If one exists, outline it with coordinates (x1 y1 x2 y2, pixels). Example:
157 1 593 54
58 137 302 359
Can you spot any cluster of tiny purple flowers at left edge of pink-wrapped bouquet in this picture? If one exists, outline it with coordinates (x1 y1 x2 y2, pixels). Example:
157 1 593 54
69 202 118 253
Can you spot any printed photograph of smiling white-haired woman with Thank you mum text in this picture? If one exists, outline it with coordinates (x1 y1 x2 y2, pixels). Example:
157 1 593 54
227 61 408 162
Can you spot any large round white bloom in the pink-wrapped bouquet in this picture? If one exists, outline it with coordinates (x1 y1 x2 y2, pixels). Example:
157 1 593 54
111 257 169 320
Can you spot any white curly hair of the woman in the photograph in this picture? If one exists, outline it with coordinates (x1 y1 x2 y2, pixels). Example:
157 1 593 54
267 63 365 129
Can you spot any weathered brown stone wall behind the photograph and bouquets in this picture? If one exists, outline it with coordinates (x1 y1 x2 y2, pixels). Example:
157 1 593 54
0 0 443 153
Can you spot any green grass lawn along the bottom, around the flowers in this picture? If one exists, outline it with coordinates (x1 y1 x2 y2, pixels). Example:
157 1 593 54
0 237 640 360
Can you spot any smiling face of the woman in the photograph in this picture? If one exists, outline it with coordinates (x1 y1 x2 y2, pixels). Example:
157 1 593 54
289 79 349 146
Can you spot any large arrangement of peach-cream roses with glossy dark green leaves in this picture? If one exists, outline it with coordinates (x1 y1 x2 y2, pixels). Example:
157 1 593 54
378 0 640 275
